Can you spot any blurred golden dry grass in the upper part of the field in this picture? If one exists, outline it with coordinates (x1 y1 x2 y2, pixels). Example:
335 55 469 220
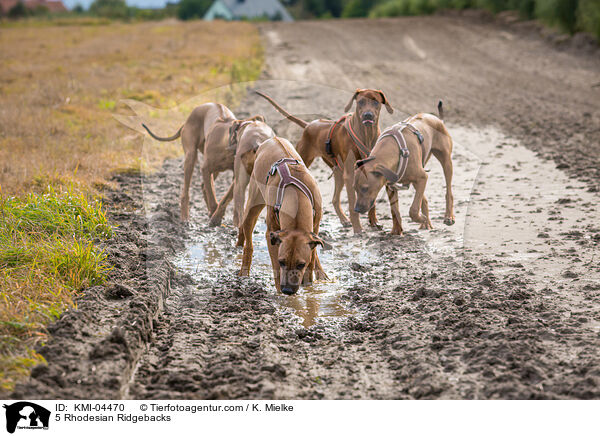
0 20 262 194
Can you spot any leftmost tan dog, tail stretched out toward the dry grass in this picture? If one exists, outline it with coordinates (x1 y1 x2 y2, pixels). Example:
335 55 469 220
142 103 264 222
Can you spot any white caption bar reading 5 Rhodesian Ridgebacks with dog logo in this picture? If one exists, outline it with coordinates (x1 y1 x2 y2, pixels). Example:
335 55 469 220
2 400 600 436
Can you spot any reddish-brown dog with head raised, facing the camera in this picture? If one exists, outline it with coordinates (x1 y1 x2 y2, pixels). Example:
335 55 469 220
257 89 394 233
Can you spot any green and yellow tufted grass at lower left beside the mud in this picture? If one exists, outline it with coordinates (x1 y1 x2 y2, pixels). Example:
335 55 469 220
0 186 112 389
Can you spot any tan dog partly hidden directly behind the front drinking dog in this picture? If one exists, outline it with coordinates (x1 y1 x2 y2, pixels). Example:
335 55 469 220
209 119 275 228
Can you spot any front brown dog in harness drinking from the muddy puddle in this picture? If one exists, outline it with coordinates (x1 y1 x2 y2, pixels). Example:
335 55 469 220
238 137 327 295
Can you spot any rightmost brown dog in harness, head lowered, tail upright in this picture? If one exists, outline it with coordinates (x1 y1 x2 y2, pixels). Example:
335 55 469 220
354 101 454 235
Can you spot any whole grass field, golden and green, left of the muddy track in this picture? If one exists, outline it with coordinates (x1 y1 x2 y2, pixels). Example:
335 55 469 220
0 20 262 389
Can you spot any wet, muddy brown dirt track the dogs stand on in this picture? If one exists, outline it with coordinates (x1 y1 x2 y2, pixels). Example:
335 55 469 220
7 17 600 399
